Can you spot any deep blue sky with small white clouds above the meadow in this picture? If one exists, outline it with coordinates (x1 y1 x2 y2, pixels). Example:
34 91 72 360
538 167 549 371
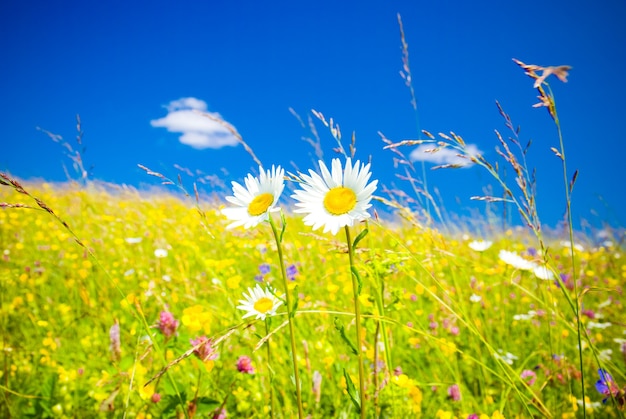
0 0 626 231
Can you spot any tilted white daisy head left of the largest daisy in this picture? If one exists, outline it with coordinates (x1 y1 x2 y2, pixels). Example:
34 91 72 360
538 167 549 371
222 166 285 228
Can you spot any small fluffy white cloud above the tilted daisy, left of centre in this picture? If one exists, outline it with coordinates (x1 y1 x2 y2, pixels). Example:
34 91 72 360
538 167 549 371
150 97 238 150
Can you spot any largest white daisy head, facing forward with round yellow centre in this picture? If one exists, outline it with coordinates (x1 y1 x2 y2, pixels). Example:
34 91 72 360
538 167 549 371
292 158 378 235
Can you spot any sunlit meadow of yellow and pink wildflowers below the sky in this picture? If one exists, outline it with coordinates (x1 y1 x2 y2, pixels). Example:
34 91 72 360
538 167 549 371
0 171 626 418
